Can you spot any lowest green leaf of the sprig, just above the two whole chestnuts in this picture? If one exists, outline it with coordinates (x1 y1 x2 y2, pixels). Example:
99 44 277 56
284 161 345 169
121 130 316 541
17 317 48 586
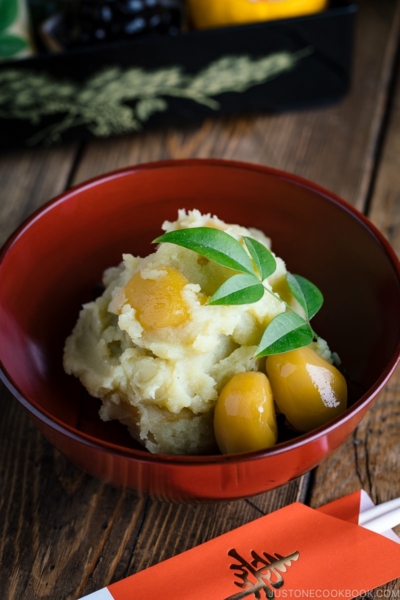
255 312 314 358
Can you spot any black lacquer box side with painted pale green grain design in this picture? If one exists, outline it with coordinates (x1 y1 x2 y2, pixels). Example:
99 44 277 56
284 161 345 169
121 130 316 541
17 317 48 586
0 0 356 151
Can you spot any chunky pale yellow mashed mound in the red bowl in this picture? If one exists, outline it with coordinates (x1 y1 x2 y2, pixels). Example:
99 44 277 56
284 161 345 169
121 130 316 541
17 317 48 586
64 210 330 454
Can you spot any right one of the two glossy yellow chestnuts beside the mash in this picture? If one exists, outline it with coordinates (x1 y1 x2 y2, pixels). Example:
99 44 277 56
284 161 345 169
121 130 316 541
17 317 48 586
266 346 347 431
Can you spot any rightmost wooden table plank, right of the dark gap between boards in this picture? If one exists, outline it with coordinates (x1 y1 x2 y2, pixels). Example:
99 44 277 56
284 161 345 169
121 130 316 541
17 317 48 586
311 18 400 598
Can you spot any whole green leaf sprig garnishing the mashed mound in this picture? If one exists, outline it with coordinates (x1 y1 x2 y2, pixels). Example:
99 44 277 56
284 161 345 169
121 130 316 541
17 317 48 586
154 227 324 357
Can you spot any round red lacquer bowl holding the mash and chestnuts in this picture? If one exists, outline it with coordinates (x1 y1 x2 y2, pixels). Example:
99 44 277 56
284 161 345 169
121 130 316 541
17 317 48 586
0 160 400 502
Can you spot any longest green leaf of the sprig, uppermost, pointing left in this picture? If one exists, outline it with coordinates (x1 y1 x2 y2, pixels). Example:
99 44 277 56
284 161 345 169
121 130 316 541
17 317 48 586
154 227 254 275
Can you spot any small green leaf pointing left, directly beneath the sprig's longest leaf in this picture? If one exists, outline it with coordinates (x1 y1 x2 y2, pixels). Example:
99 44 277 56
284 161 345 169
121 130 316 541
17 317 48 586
208 273 265 304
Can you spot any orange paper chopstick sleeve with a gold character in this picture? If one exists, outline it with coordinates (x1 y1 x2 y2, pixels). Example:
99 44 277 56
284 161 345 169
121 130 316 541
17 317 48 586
80 490 400 600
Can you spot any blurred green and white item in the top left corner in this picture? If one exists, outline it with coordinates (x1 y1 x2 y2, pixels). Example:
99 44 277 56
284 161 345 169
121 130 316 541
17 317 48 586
0 0 33 60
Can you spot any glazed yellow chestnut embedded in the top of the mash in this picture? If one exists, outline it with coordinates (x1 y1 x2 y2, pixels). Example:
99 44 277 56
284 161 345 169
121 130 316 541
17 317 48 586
125 267 189 331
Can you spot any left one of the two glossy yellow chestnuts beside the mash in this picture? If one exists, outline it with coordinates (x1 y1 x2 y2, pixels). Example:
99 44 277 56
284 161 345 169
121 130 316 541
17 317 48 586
214 371 278 454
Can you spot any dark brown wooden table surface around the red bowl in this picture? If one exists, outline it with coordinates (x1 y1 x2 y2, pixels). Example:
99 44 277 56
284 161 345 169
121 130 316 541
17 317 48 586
0 0 400 600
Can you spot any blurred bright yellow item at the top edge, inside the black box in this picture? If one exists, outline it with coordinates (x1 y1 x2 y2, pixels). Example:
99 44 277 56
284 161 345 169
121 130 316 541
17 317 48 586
186 0 328 29
